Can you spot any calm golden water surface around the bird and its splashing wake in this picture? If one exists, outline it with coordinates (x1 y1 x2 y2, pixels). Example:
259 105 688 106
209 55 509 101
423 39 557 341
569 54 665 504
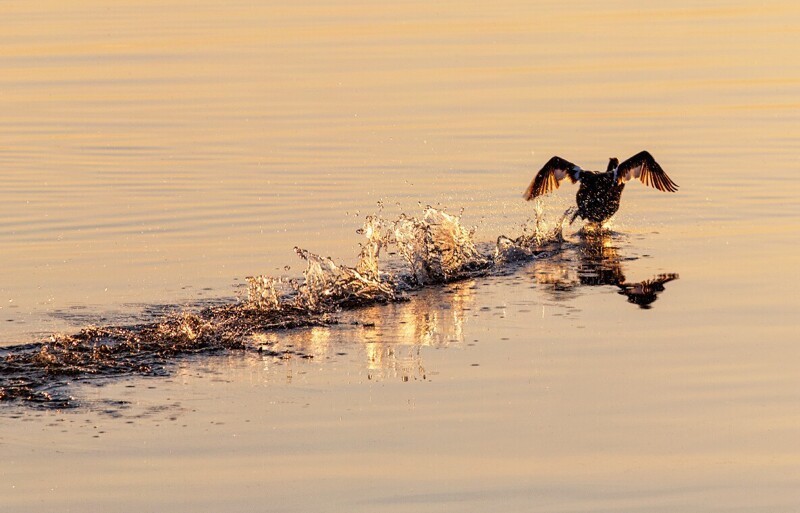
0 1 800 511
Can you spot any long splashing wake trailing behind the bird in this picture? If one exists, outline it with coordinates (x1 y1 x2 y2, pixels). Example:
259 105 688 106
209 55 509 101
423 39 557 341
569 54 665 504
0 207 566 408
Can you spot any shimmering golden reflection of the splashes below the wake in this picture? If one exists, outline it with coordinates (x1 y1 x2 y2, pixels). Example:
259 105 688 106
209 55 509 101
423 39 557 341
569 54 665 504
254 280 475 382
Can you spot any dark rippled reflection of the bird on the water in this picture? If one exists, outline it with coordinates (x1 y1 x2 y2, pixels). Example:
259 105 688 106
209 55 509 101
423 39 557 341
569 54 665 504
534 228 678 309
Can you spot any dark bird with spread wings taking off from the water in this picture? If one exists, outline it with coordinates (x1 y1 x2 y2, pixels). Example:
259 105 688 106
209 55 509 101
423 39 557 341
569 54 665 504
522 151 678 225
